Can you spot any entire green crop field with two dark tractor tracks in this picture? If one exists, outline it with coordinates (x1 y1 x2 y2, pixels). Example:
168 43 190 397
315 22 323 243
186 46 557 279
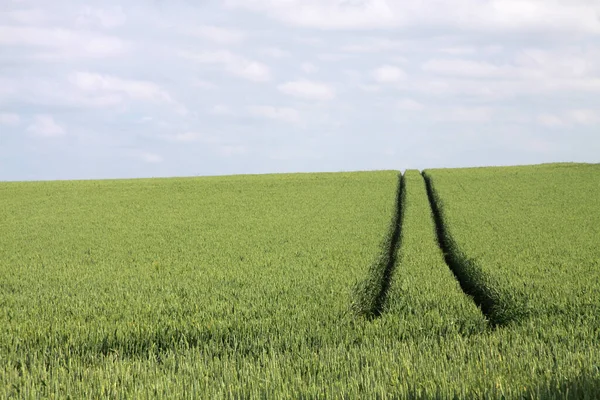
0 164 600 399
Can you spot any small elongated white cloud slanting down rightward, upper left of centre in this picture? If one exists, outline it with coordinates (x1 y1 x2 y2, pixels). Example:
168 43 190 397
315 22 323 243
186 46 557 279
180 50 271 82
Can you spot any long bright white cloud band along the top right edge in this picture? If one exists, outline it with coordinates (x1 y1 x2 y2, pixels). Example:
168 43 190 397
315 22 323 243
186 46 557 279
226 0 600 34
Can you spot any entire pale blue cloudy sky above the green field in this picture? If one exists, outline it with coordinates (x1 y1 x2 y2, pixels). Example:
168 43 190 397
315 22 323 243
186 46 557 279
0 0 600 181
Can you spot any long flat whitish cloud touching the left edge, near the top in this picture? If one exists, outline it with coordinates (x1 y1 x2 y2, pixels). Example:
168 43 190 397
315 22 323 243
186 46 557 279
0 26 127 59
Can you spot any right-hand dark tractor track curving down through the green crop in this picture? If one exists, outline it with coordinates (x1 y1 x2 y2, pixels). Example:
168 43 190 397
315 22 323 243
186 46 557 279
421 170 527 327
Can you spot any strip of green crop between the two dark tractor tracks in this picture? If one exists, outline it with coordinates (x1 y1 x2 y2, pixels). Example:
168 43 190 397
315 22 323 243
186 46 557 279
389 171 485 336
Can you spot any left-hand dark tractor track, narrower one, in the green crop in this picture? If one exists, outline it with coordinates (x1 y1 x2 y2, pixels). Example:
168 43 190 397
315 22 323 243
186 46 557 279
351 171 406 319
